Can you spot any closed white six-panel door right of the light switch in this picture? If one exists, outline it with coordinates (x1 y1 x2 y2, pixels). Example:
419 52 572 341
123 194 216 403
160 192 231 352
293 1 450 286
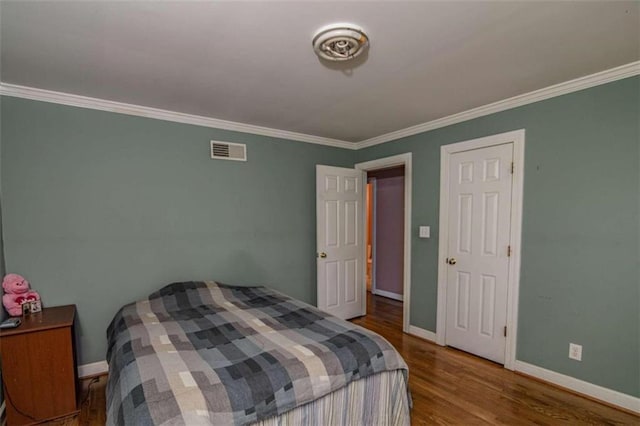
446 143 513 364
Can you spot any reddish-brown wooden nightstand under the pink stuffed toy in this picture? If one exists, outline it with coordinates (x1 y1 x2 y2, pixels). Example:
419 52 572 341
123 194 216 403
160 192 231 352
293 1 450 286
0 305 79 426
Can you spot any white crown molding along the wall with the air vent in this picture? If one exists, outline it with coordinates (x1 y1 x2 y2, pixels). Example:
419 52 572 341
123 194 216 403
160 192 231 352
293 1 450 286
0 82 356 149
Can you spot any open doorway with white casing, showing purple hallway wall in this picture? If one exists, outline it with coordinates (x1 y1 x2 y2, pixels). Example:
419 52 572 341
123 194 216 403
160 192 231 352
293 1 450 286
356 153 411 332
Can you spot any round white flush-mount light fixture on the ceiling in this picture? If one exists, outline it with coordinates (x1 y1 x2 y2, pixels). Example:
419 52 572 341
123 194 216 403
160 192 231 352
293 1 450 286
312 24 369 61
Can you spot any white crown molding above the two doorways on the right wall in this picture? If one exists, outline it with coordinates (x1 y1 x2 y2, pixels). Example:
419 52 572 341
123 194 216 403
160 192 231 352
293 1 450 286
356 61 640 149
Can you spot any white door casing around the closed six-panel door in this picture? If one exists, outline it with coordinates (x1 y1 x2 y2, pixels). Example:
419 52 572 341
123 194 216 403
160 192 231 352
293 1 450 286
436 129 525 370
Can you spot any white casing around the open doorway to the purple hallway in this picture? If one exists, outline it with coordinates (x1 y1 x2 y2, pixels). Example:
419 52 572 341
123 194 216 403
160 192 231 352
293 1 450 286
355 152 412 333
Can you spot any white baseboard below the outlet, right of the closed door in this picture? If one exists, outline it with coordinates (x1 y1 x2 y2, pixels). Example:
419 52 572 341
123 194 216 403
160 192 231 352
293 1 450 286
515 361 640 413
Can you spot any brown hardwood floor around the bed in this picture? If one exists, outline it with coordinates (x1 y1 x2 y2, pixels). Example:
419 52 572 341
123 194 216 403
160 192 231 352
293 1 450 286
50 296 640 426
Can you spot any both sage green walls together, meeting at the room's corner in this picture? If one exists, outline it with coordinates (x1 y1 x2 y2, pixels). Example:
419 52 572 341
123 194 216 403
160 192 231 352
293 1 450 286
1 77 640 396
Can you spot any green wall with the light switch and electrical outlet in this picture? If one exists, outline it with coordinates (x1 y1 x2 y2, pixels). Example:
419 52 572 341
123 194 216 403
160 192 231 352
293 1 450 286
356 77 640 396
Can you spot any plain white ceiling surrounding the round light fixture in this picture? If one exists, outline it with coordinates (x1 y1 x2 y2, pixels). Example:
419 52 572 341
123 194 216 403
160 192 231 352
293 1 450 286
0 1 640 142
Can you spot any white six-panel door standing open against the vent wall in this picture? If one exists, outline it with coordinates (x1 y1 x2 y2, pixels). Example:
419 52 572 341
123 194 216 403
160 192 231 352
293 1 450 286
316 165 366 319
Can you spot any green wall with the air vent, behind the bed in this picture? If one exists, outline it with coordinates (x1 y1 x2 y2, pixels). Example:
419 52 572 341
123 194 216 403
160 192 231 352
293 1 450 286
2 97 355 364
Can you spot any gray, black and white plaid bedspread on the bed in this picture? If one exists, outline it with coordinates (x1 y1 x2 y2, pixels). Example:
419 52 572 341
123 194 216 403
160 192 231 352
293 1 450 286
107 282 407 425
